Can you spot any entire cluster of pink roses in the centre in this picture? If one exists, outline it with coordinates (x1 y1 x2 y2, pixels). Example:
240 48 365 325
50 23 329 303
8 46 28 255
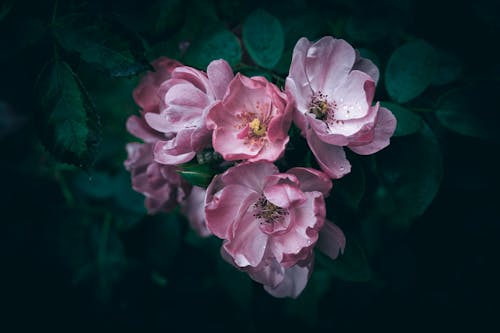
125 37 396 297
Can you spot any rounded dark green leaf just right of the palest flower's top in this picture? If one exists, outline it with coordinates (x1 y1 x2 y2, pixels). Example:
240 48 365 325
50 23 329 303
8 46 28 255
385 40 437 103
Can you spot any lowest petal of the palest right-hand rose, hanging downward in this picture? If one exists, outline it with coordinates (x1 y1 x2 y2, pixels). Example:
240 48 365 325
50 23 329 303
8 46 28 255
307 130 351 179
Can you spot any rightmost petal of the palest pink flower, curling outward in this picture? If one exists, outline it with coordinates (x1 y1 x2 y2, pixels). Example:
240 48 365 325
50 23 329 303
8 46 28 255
349 107 397 155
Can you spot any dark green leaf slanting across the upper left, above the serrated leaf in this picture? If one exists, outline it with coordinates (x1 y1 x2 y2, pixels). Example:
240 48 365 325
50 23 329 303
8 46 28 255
53 16 150 77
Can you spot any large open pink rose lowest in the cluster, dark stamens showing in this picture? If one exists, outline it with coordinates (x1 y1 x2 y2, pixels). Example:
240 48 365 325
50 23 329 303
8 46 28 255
205 161 332 269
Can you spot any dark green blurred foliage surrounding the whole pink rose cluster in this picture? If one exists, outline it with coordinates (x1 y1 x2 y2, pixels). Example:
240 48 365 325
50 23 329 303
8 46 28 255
0 0 500 332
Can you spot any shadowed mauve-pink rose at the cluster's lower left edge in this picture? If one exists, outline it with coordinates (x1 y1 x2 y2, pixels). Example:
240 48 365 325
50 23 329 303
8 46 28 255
125 142 191 214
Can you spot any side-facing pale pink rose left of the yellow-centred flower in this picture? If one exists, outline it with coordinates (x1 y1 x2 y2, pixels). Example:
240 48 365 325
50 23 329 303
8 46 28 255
144 60 233 164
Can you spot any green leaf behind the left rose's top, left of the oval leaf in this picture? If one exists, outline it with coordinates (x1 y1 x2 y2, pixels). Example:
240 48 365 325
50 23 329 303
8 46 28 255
183 25 241 69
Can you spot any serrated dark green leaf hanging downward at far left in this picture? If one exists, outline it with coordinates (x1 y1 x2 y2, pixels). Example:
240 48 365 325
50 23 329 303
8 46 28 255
36 61 101 168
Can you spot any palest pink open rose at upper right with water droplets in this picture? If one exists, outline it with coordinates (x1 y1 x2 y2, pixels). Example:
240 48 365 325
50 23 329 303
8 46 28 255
286 37 396 178
